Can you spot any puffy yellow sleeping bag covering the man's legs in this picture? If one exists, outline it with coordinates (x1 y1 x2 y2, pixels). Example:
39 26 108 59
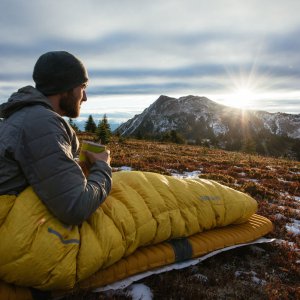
0 172 257 290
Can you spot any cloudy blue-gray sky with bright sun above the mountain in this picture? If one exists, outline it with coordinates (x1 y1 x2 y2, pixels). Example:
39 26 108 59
0 0 300 123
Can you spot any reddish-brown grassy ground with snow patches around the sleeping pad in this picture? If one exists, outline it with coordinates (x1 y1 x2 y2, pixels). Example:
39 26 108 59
67 139 300 299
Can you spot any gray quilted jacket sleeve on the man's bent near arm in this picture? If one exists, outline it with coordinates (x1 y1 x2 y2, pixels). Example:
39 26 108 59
16 110 112 225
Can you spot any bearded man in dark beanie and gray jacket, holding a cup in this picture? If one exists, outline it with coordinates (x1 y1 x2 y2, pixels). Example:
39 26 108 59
0 51 112 225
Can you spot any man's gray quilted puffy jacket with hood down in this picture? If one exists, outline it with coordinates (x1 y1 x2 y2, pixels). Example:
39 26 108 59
0 86 112 224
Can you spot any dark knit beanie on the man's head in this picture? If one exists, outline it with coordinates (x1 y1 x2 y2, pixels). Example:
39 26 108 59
32 51 88 96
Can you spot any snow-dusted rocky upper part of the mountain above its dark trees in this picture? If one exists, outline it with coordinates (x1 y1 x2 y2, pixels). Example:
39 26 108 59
117 95 300 139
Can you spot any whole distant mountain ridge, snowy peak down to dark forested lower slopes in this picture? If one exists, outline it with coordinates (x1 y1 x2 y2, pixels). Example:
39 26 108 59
116 96 300 159
